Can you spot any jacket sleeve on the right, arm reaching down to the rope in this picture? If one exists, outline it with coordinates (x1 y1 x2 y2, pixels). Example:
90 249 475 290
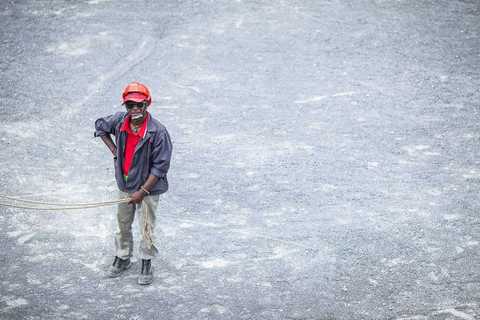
150 129 172 178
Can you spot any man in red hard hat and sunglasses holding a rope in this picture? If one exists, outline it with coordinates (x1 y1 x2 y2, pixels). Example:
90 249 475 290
95 82 172 285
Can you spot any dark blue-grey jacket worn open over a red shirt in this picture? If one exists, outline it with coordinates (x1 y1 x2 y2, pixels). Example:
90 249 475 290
95 112 172 194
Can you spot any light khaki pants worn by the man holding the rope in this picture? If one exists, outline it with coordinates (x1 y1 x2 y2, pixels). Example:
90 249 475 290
115 191 160 259
